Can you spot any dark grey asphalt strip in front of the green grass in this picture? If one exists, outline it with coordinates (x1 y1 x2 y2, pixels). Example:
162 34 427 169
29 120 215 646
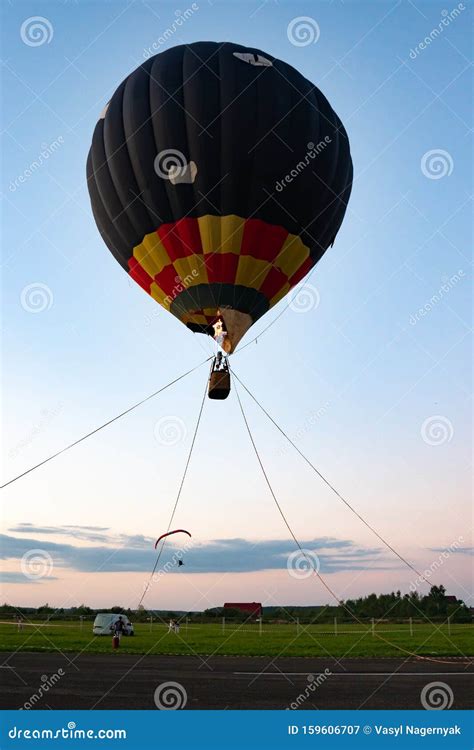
0 652 474 710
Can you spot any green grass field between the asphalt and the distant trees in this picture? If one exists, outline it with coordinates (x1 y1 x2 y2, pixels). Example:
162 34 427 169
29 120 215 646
0 622 474 657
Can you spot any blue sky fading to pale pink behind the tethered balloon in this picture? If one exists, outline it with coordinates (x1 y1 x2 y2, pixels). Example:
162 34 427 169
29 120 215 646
2 0 472 607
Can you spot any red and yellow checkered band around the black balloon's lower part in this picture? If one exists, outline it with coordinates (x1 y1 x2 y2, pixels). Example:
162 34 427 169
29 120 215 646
129 214 314 325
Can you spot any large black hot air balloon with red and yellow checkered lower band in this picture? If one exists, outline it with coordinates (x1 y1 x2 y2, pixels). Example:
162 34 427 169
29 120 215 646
87 42 352 397
